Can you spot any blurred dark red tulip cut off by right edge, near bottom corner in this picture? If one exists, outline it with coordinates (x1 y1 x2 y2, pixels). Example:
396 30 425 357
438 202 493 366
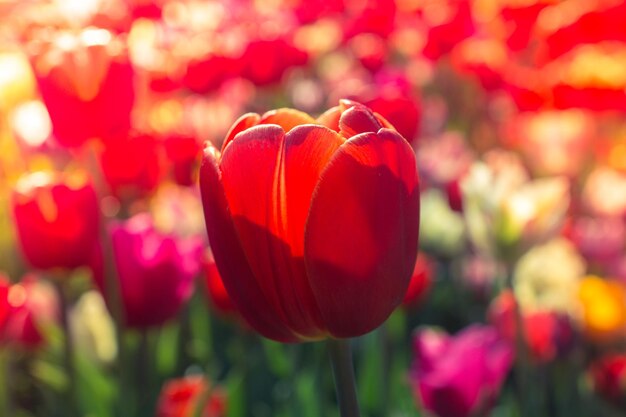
589 354 626 406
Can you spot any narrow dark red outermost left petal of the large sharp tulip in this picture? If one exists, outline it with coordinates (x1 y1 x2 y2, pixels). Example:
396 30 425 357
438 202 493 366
200 143 297 342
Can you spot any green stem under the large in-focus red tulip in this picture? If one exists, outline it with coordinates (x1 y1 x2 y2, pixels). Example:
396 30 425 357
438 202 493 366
328 339 360 417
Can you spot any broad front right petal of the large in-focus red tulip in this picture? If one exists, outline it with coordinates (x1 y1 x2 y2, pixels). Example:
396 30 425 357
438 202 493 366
304 129 419 337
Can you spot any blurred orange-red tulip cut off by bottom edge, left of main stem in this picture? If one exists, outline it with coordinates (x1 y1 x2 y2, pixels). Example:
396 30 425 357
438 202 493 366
156 376 227 417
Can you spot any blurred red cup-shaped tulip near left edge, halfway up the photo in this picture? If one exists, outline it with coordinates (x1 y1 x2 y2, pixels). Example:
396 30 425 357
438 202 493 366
12 172 100 269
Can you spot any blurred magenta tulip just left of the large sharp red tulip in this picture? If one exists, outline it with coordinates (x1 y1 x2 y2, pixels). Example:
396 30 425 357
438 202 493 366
103 214 202 328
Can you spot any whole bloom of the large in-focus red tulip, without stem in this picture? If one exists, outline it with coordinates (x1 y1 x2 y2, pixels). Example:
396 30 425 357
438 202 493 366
200 100 419 342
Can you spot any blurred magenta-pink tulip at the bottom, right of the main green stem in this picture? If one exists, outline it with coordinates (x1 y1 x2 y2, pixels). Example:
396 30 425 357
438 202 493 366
410 325 514 417
